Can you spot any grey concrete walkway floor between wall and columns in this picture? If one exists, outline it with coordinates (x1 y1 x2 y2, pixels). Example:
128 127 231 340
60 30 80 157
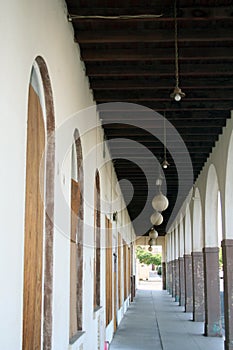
110 282 224 350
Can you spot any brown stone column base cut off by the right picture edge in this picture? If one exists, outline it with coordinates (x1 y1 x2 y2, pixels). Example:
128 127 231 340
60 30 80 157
222 239 233 350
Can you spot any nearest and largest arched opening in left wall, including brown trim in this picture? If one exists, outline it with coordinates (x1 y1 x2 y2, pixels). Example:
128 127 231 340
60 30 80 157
22 57 55 350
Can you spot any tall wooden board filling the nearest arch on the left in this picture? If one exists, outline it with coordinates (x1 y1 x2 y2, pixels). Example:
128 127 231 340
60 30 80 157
23 85 45 350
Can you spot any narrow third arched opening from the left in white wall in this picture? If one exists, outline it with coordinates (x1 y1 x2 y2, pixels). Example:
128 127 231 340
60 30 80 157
93 171 100 310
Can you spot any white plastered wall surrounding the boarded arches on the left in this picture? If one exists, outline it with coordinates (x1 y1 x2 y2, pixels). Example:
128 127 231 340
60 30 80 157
0 0 134 350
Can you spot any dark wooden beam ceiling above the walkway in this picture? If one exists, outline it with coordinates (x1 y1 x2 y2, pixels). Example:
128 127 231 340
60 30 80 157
66 0 233 234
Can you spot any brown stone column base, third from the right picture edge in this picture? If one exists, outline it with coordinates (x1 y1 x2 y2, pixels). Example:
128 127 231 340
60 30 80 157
192 252 205 322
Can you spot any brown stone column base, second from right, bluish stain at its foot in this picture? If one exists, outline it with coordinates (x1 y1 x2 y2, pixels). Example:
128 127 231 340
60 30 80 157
203 247 222 337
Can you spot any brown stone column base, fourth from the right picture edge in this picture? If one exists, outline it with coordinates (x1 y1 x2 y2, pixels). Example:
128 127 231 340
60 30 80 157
184 254 193 312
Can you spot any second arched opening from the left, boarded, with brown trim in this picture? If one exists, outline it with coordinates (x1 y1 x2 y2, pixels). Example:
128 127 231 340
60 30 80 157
70 129 83 343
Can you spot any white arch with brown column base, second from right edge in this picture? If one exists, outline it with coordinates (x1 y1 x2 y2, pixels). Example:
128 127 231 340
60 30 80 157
203 164 222 337
